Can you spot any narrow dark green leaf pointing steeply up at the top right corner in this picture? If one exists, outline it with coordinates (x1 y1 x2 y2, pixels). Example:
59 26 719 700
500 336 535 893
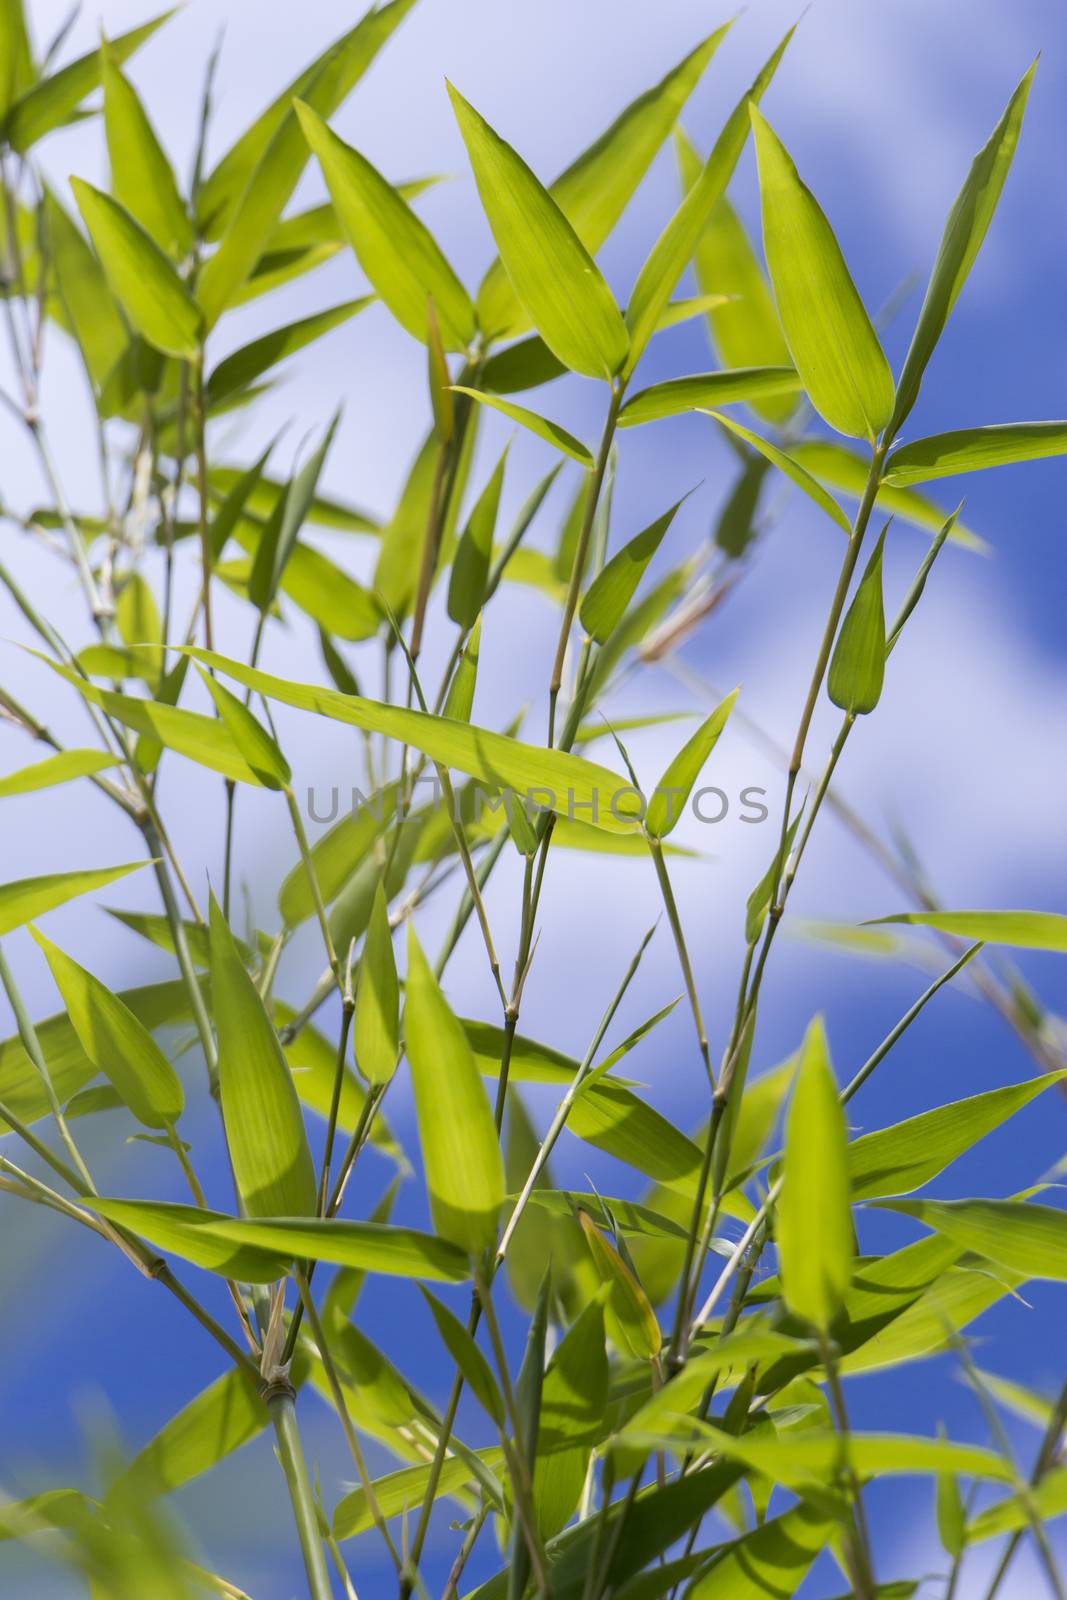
891 61 1037 434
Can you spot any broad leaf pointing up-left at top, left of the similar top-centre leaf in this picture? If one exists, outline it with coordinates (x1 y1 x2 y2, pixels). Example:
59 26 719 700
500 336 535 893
296 101 475 350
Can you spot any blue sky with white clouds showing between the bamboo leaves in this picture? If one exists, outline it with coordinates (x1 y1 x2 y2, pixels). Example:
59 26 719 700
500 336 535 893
0 0 1067 1600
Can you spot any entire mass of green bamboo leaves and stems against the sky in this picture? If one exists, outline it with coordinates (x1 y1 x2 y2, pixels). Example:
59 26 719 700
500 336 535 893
0 0 1067 1600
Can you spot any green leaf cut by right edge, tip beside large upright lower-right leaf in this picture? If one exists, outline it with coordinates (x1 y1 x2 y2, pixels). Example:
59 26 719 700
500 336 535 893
875 1200 1067 1283
